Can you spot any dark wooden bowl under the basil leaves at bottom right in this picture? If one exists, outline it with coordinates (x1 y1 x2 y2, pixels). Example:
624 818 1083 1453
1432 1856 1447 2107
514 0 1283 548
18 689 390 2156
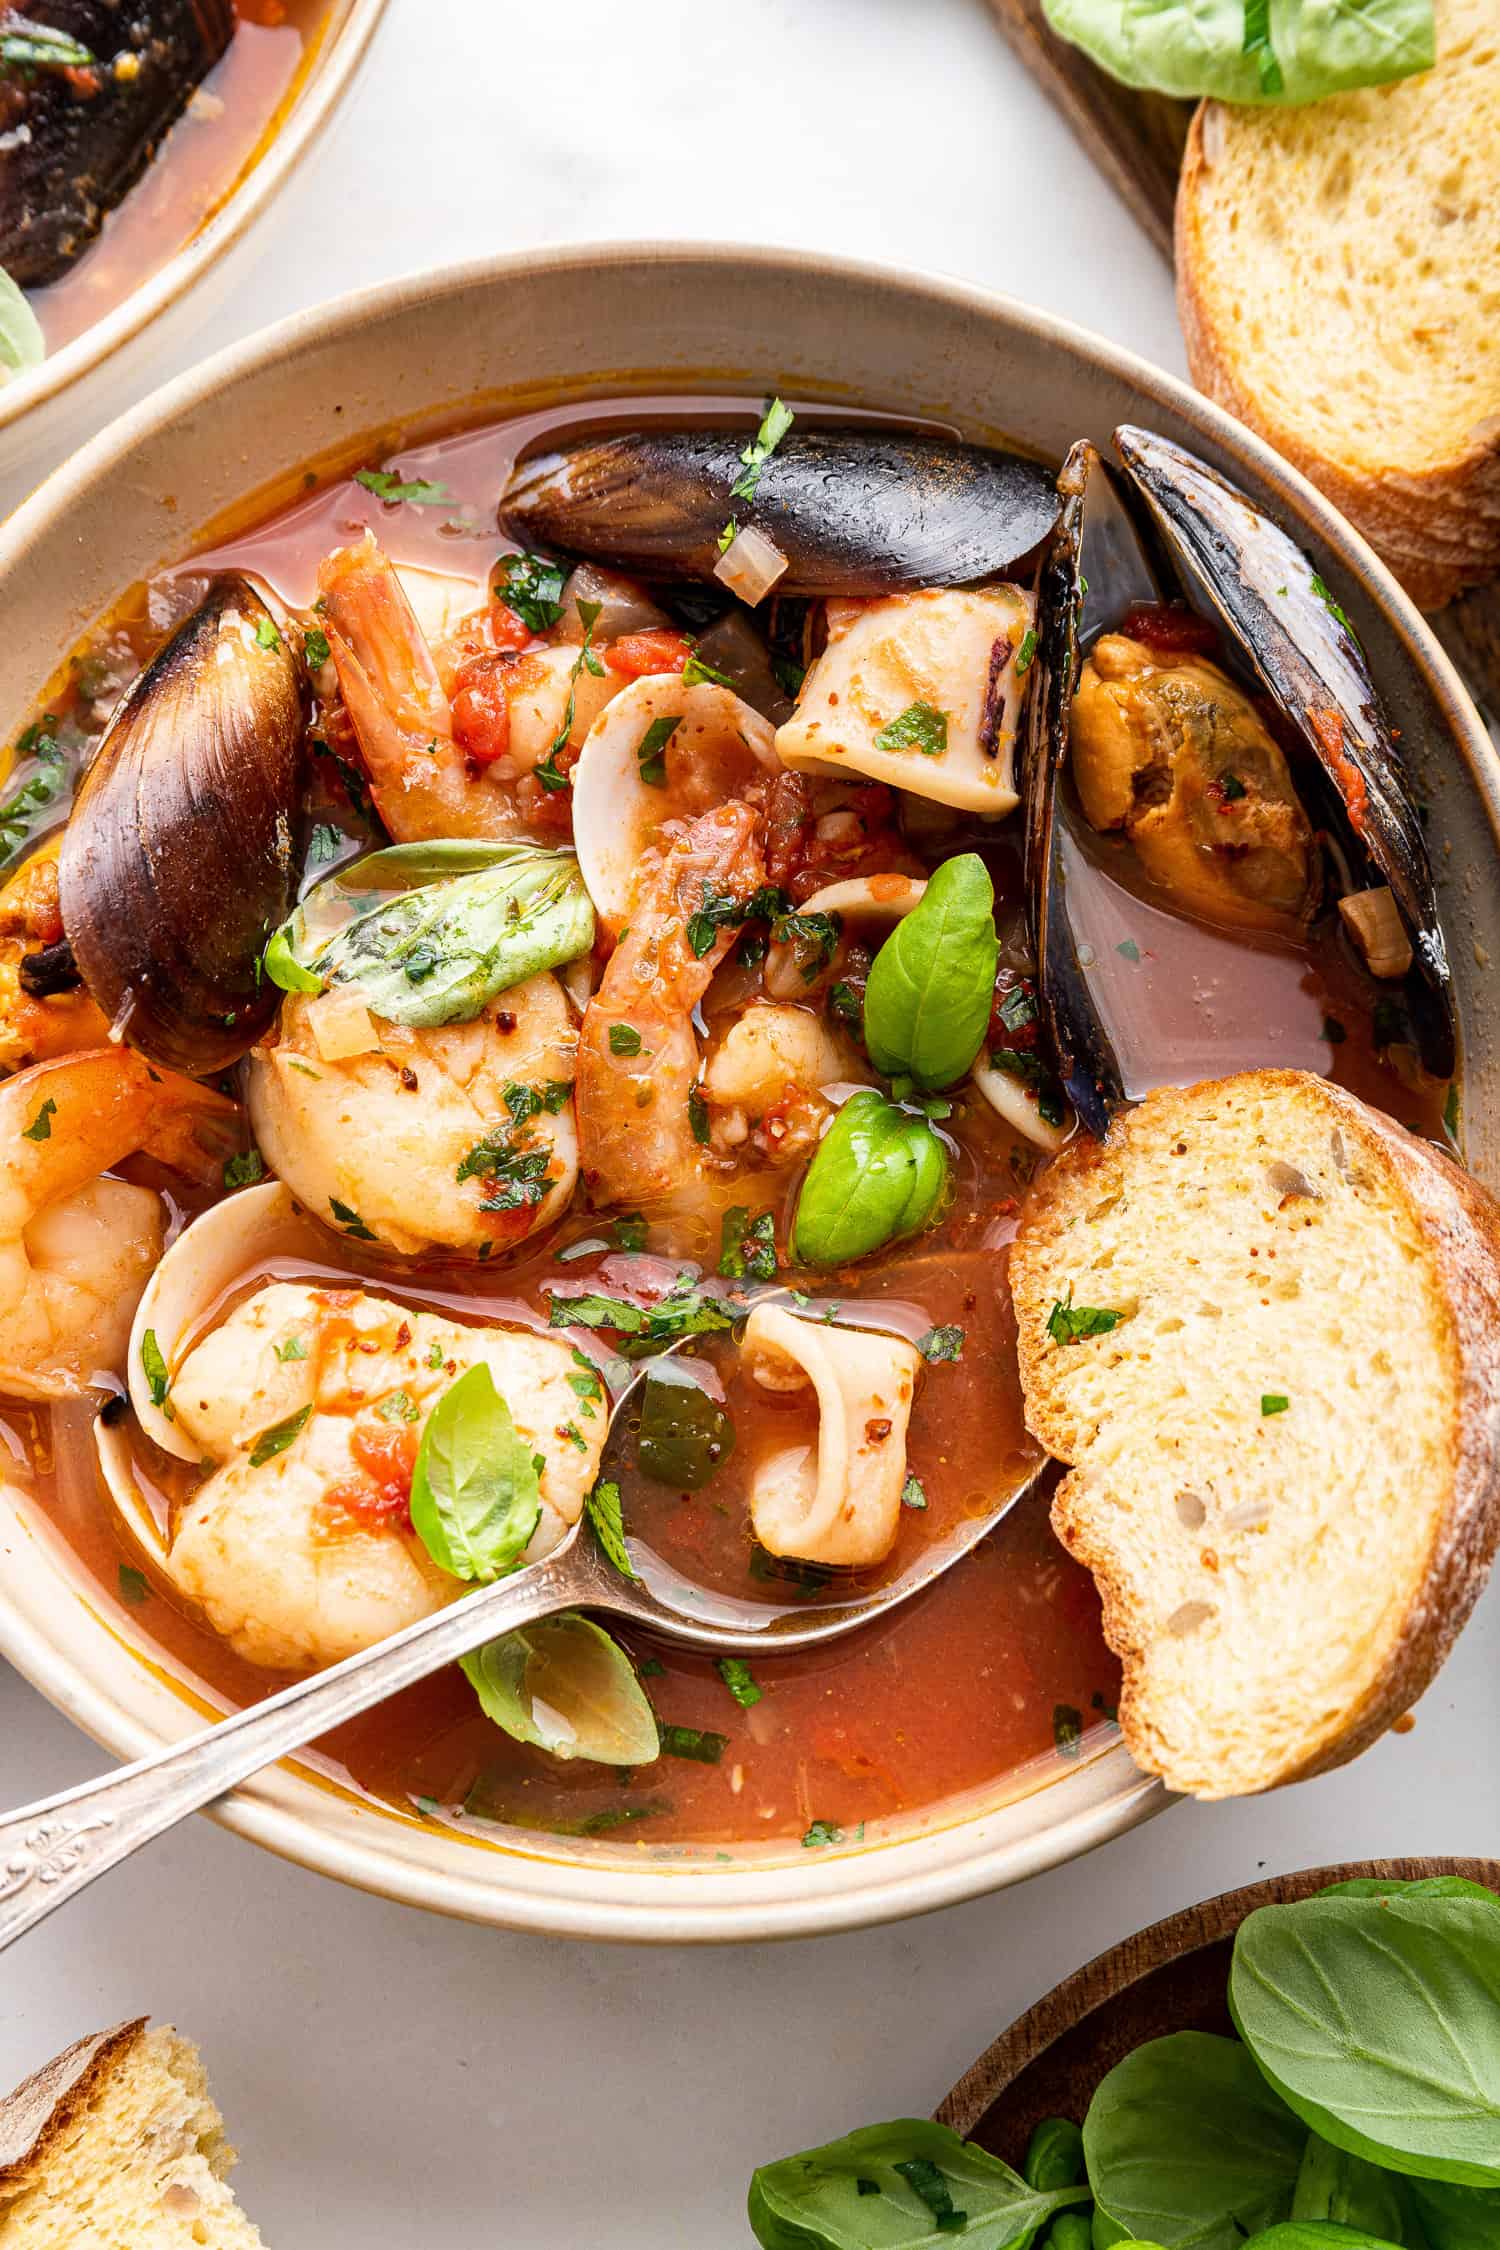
938 1859 1500 2171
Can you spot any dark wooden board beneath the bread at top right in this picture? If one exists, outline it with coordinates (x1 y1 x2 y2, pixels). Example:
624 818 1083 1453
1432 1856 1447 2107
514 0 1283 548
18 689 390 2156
990 0 1500 747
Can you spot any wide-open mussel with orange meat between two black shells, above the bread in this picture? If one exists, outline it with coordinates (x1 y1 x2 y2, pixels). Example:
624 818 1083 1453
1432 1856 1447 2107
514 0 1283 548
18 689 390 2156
1023 428 1457 1136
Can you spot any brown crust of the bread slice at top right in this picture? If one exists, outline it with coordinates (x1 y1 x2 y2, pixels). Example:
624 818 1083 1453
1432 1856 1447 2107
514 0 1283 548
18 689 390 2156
1174 101 1500 610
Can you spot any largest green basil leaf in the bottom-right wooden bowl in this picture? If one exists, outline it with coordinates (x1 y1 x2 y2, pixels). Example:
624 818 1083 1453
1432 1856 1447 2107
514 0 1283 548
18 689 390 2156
1230 1892 1500 2187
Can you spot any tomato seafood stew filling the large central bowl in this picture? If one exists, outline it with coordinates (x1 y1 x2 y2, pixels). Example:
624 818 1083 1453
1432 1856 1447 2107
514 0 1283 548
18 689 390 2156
0 403 1457 1854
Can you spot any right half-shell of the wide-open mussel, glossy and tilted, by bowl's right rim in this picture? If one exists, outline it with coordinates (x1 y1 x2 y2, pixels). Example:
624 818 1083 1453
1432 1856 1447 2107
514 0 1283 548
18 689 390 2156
1115 425 1457 1078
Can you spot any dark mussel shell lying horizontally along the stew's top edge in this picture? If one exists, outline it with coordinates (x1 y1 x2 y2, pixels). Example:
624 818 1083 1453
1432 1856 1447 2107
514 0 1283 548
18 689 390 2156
499 430 1057 596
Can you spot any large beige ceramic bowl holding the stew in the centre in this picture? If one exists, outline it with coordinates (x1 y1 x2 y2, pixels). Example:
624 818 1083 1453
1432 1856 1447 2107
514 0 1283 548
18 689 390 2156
0 245 1500 1944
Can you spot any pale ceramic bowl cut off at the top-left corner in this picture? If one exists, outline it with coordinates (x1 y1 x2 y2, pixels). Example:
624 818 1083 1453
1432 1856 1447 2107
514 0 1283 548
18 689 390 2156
0 0 385 475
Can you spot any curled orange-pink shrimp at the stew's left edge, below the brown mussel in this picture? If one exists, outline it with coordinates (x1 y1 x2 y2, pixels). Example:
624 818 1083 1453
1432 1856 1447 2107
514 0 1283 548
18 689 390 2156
0 1046 236 1400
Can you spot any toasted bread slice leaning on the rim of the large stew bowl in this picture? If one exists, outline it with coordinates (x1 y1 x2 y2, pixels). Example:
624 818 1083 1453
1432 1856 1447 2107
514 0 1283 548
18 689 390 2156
1010 1071 1500 1798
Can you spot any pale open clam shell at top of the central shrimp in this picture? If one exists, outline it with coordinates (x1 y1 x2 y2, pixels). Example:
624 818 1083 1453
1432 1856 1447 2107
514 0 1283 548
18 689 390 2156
573 673 780 936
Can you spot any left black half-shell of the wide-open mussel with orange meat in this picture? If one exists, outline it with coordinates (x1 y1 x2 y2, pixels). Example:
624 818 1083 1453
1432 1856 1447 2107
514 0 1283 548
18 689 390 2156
1021 441 1124 1139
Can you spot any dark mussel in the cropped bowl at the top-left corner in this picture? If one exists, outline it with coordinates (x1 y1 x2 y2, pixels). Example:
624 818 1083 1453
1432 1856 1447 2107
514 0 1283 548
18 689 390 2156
0 0 236 288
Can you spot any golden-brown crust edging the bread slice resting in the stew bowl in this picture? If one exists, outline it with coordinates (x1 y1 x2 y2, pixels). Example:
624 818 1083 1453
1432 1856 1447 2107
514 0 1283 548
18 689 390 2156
1012 1071 1500 1796
